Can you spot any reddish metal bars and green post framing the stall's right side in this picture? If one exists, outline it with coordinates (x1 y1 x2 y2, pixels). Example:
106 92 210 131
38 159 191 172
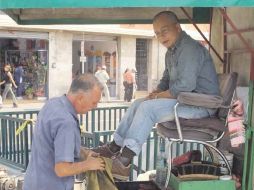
160 7 254 190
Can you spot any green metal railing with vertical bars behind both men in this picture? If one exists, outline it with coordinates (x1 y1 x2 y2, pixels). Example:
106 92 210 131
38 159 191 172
0 106 203 180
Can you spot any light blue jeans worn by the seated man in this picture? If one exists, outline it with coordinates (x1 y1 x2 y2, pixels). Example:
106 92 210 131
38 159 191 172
114 99 216 155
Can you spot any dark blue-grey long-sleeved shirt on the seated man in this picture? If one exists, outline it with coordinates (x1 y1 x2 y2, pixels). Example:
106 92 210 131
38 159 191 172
157 31 219 98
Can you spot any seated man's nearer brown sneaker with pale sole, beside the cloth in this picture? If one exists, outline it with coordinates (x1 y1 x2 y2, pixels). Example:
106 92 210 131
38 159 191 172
112 155 131 181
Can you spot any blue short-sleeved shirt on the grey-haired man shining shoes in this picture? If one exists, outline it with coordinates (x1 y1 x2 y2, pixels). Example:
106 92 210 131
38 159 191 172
24 95 81 190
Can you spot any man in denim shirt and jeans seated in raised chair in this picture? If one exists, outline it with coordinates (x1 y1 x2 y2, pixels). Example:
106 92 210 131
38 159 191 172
94 11 219 179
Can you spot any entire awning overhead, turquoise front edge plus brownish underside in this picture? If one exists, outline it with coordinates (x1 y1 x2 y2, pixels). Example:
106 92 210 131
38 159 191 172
0 0 254 24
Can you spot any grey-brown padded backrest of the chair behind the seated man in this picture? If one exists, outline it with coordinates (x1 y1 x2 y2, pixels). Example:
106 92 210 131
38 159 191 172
218 72 238 119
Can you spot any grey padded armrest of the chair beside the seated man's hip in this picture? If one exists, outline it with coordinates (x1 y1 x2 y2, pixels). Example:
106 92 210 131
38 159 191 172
177 92 223 108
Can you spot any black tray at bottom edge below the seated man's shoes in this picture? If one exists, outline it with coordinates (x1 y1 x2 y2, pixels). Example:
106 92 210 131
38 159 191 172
115 181 161 190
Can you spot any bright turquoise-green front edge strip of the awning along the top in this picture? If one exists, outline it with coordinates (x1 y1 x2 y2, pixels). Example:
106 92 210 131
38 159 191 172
0 0 254 9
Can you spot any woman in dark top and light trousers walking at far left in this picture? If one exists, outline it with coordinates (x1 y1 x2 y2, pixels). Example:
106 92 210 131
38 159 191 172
0 65 18 107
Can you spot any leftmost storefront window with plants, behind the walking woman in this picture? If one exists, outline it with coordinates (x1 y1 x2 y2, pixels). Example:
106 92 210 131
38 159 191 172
0 39 48 99
